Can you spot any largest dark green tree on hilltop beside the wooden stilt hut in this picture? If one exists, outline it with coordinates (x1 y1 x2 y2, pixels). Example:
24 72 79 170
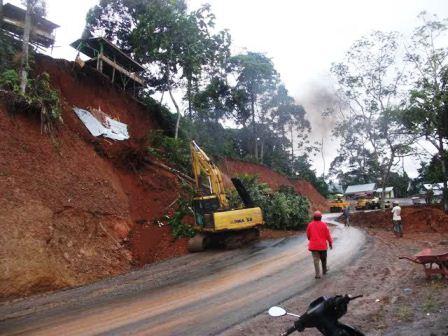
84 0 230 138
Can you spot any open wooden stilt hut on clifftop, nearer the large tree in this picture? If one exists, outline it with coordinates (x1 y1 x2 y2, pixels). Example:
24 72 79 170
70 37 145 95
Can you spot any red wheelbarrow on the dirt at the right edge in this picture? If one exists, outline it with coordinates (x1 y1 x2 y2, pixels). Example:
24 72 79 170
398 248 448 279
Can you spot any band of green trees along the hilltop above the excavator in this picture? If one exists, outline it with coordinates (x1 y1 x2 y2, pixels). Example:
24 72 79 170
84 0 309 174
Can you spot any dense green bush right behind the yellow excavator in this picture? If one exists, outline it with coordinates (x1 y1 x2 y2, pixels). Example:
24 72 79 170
229 175 310 230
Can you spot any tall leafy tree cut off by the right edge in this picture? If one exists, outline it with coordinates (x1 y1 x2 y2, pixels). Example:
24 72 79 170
404 12 448 212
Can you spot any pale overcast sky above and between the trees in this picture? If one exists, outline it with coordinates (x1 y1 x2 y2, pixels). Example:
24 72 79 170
4 0 448 175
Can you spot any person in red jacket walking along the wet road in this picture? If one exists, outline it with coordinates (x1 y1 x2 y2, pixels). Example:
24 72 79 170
306 211 333 279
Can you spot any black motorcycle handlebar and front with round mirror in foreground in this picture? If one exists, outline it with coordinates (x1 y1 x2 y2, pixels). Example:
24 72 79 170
269 295 365 336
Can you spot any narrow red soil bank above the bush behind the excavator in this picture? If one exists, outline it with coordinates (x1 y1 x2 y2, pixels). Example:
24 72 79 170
220 159 328 211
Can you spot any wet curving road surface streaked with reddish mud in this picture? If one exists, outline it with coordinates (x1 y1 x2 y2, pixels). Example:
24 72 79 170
0 217 365 336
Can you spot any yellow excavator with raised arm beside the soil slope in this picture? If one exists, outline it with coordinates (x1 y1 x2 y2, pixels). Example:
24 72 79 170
188 141 263 252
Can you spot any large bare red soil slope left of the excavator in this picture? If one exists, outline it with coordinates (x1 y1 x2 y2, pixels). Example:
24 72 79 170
0 56 186 298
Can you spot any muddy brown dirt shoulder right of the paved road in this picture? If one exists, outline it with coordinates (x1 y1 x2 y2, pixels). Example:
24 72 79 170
223 215 448 336
